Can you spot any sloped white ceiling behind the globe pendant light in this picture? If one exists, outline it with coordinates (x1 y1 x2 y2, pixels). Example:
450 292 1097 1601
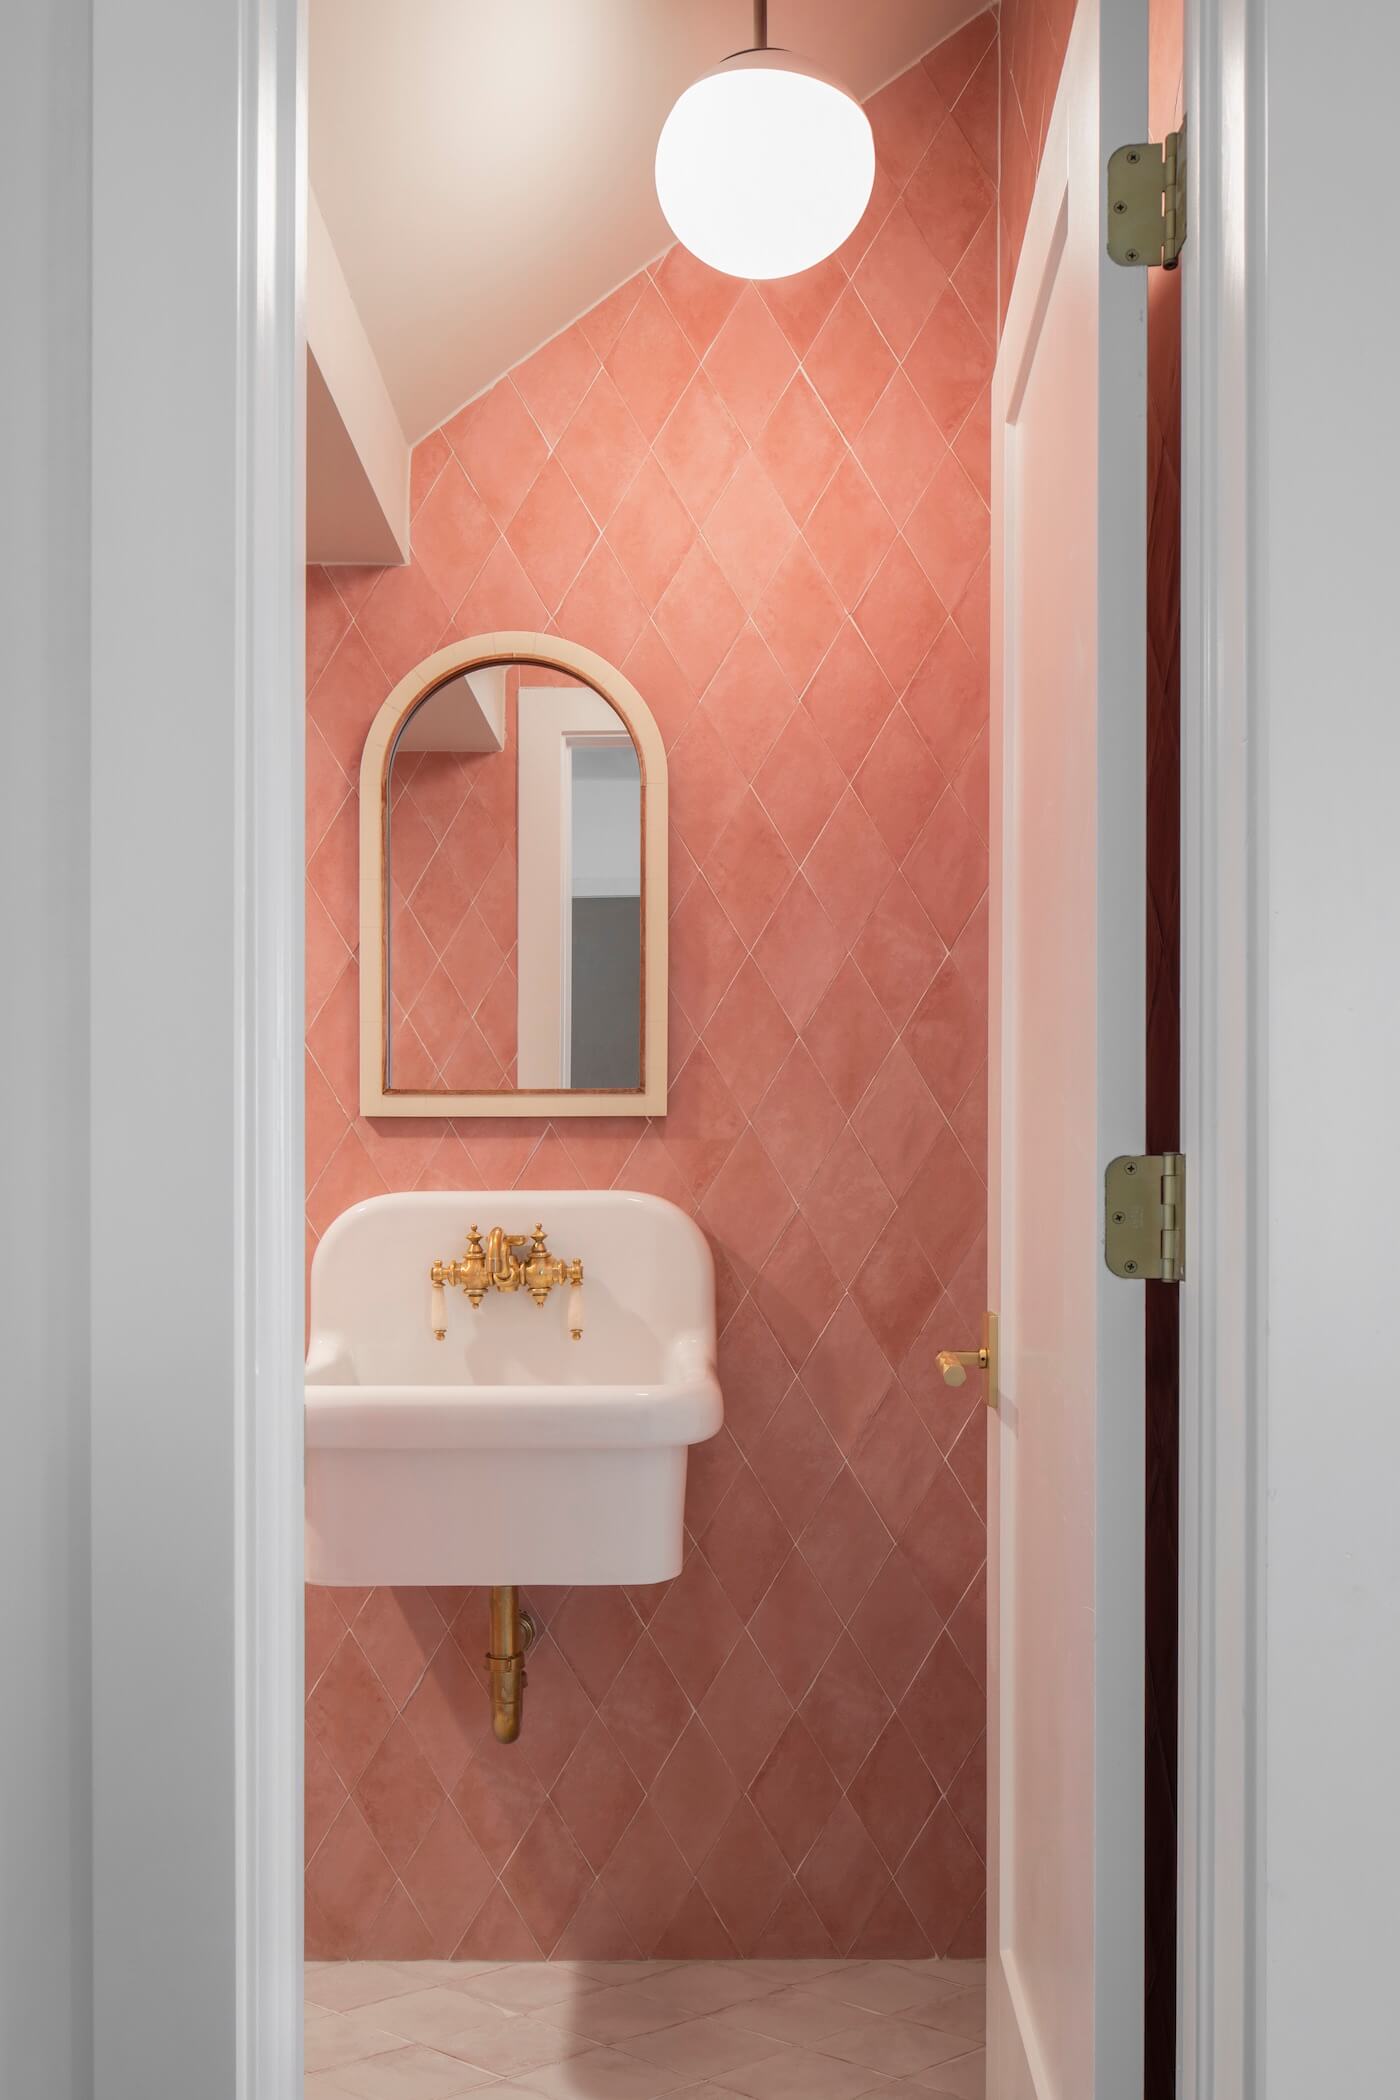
311 0 984 441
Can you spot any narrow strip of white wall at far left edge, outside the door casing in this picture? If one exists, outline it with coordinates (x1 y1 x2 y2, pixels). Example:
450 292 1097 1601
0 0 92 2100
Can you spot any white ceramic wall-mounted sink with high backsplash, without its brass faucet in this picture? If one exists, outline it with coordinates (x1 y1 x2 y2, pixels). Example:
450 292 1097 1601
306 1189 722 1586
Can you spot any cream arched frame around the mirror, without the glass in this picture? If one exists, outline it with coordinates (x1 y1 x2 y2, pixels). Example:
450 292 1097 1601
359 632 670 1115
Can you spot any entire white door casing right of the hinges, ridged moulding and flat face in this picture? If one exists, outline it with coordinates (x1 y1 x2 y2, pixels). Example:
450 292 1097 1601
1180 0 1400 2100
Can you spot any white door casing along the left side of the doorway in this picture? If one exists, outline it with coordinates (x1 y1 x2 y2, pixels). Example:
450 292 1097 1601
90 0 304 2100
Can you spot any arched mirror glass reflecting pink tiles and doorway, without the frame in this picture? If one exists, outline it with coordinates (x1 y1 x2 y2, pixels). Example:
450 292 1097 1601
384 664 644 1094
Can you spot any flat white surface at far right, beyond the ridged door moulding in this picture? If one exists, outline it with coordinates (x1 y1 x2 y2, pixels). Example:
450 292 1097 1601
1250 0 1400 2100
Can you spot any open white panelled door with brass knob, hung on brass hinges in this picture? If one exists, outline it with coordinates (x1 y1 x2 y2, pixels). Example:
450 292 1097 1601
987 0 1165 2100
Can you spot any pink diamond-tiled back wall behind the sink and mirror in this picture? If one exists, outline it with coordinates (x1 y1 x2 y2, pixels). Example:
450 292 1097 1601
306 15 997 1959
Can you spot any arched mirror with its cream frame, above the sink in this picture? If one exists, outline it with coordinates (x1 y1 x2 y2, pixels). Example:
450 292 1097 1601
359 634 665 1115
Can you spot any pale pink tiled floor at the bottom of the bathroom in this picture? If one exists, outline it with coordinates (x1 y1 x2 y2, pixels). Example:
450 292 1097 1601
306 1959 987 2100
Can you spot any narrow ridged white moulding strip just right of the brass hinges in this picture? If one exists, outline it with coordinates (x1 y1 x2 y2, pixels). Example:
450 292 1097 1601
1178 0 1264 2100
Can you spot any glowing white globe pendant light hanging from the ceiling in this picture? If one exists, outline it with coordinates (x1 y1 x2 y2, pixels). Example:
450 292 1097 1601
657 0 875 277
